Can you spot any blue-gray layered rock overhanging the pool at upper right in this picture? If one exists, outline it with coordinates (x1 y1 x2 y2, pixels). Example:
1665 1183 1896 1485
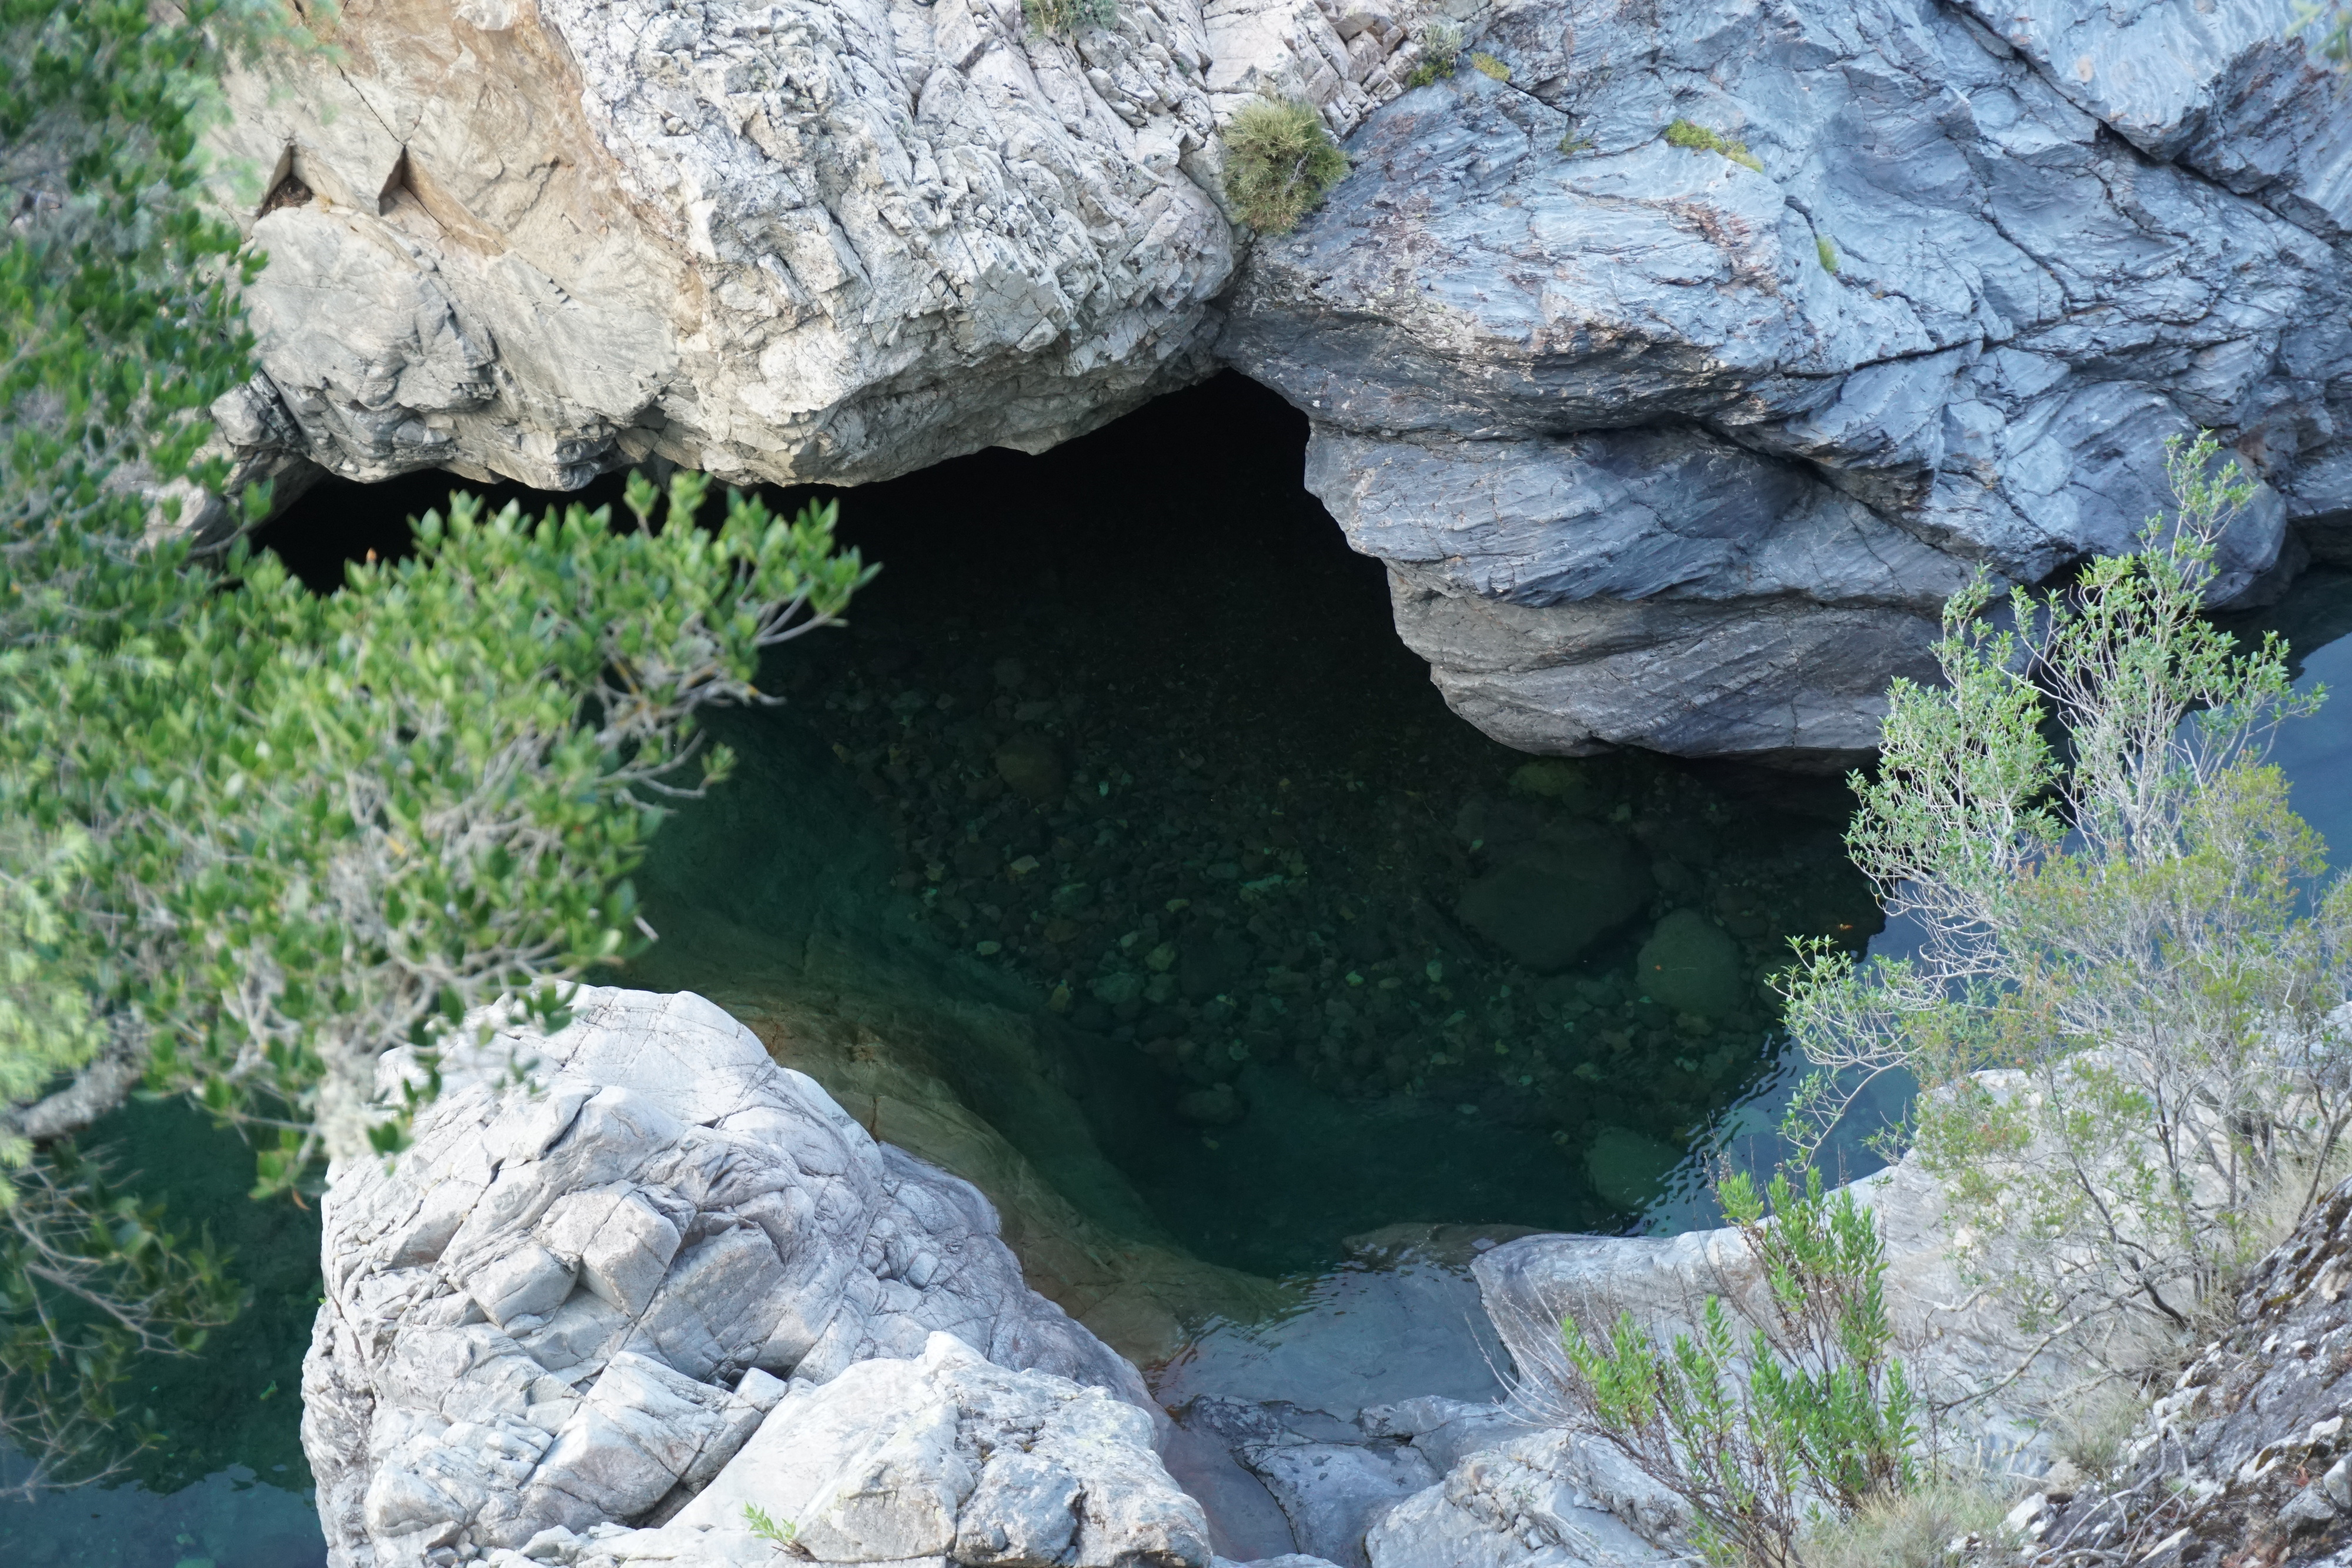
1218 0 2352 757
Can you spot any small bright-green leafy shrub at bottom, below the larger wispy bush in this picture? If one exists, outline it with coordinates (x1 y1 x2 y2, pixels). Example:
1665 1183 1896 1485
1555 1171 1917 1568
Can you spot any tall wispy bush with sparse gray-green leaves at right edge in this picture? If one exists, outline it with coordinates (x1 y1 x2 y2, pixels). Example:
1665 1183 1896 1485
1788 437 2352 1366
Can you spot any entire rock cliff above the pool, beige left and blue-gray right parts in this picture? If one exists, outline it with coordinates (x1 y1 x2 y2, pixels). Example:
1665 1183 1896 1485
219 0 2352 762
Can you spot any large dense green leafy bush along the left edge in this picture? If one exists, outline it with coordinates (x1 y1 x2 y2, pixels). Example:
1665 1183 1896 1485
0 0 866 1483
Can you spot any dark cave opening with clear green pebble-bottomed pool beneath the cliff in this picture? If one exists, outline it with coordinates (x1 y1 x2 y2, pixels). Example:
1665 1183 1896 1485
266 374 1877 1274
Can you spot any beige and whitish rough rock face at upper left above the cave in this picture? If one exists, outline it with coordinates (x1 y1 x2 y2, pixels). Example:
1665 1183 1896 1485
219 0 1449 489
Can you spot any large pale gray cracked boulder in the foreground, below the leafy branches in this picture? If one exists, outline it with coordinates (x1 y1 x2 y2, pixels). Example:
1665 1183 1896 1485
303 989 1176 1568
